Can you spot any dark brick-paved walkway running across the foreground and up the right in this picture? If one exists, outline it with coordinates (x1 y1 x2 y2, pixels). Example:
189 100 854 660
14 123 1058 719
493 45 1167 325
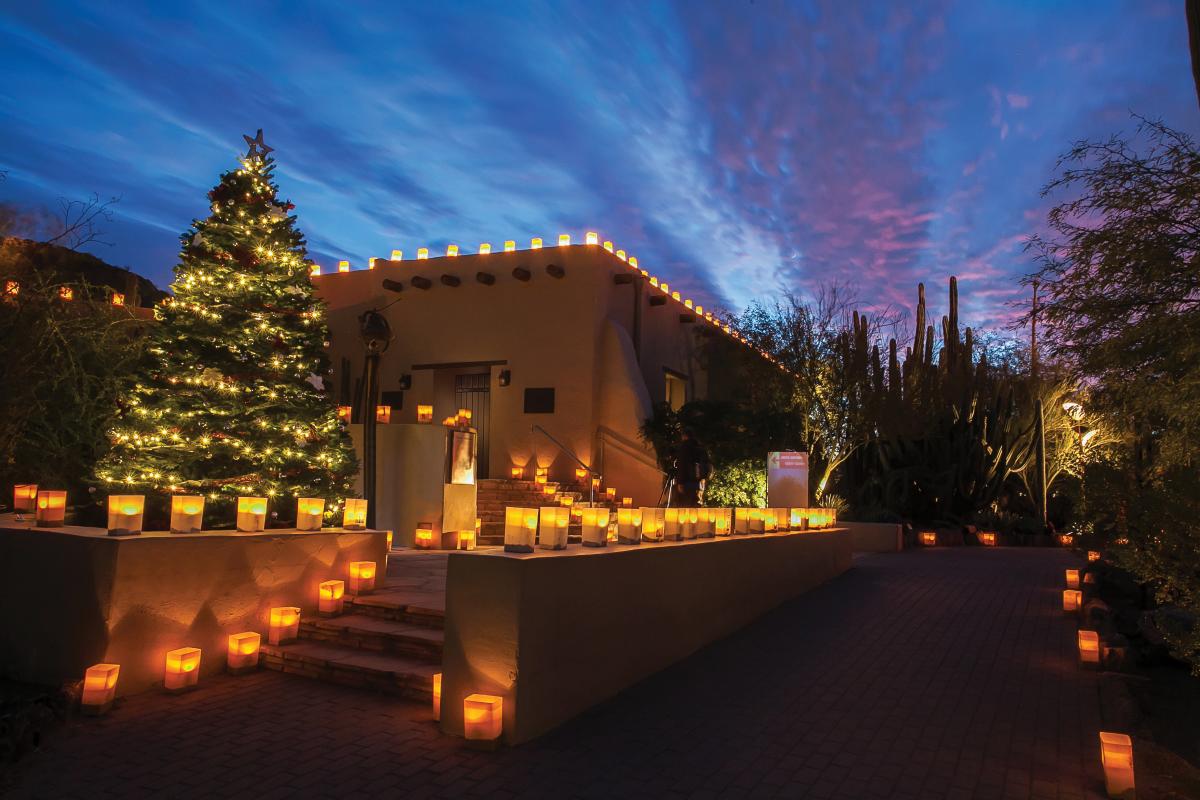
7 548 1103 800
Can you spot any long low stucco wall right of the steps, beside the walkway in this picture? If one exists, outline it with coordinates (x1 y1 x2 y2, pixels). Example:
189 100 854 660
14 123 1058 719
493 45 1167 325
442 529 852 744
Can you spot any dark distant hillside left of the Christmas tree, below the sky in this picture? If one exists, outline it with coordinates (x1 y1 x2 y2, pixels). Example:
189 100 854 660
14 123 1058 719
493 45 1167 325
0 236 167 308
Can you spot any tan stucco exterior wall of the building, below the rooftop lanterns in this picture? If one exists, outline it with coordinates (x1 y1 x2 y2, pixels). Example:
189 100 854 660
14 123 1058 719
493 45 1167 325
313 242 707 495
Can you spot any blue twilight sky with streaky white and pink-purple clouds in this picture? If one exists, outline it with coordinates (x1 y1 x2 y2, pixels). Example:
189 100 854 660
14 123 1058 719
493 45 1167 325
0 0 1200 324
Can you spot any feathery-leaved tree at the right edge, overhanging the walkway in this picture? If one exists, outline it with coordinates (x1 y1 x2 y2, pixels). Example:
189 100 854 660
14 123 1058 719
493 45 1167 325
1030 119 1200 674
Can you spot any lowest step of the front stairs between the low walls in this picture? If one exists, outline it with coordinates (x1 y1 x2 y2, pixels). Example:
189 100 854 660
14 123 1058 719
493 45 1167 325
263 640 442 702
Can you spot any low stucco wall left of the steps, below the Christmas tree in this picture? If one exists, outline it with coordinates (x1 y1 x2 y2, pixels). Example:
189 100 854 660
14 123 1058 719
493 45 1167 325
0 525 386 694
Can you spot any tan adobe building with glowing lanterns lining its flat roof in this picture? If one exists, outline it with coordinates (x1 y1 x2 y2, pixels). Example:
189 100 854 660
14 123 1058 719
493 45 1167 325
313 234 777 543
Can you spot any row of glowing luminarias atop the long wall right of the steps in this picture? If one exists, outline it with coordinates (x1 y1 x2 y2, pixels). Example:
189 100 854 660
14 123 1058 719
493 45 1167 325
504 506 838 553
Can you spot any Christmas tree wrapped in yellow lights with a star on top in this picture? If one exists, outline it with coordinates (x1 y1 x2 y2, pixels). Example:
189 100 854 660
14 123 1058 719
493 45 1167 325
96 131 356 521
